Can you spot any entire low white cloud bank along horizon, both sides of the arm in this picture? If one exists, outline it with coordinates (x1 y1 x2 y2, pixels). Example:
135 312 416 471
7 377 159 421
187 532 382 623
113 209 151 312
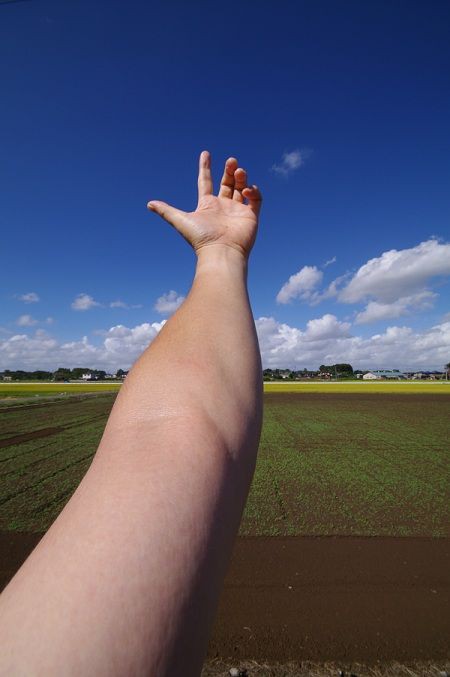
0 314 450 371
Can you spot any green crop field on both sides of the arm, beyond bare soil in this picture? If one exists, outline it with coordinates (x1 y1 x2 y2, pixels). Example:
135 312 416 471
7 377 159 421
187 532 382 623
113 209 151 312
0 384 450 536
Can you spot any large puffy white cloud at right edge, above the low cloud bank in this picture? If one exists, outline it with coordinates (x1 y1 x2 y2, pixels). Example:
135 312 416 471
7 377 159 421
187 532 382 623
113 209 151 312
338 240 450 303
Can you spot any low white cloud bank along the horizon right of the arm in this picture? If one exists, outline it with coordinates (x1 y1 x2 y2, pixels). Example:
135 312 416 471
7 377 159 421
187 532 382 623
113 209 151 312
256 315 450 369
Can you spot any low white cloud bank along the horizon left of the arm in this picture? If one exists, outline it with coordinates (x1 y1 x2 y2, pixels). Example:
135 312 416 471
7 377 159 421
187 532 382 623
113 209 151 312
0 321 165 371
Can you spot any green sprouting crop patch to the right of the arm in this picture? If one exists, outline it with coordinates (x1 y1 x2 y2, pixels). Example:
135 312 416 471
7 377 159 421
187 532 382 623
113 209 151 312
241 393 450 536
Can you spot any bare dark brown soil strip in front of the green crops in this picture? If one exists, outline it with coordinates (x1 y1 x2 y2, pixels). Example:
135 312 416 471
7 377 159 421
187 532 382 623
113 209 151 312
0 533 450 674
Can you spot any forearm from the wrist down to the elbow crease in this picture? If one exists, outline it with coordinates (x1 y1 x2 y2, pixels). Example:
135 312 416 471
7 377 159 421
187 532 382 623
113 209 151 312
108 246 262 462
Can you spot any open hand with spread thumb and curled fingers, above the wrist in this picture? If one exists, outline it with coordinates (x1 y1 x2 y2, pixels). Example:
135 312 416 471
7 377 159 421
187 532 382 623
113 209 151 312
147 151 262 258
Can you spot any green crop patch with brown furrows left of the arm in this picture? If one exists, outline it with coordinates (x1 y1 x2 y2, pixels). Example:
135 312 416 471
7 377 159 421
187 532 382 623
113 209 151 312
0 393 114 532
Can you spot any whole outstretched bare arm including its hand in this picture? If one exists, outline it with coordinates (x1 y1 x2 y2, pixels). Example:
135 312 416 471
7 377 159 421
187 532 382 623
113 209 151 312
0 151 262 677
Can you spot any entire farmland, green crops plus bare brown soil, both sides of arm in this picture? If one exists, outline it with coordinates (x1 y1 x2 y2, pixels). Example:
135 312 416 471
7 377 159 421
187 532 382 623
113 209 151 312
0 383 450 662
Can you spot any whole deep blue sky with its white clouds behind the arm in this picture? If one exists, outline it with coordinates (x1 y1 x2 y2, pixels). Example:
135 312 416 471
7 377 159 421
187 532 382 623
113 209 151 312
0 0 450 369
